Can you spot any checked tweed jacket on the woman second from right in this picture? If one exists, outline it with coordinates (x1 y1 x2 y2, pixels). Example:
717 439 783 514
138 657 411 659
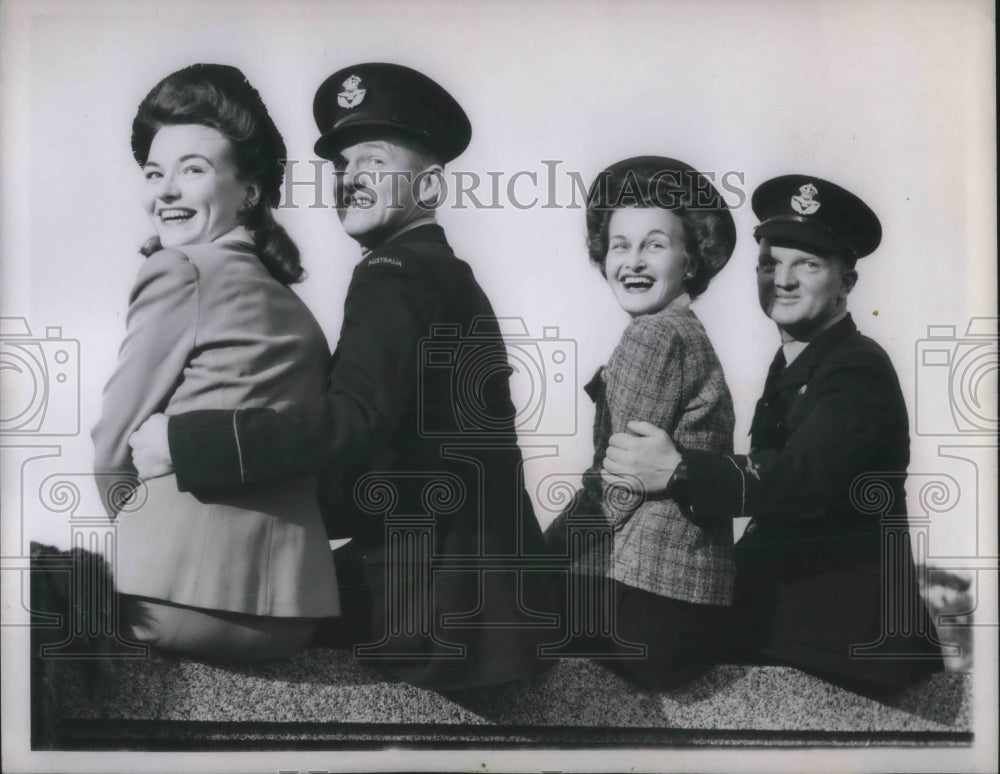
572 295 735 605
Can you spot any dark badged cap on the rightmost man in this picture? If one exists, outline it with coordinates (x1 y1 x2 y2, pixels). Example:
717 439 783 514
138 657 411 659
750 175 882 260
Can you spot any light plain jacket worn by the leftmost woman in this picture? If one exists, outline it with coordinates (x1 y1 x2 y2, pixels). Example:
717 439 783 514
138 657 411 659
92 228 338 617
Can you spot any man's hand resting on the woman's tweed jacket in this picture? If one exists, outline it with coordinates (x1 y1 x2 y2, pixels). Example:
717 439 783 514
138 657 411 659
601 422 681 495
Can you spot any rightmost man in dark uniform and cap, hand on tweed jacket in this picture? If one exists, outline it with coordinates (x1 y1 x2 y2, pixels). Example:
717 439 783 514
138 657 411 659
603 175 941 691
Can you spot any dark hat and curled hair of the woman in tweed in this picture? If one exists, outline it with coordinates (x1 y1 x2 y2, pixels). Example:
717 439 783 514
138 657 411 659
587 156 736 298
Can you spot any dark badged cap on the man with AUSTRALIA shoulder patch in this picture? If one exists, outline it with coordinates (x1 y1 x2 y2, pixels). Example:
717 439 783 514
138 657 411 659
313 62 472 163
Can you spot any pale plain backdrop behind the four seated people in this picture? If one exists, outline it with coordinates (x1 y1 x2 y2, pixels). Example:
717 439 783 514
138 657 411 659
0 0 997 770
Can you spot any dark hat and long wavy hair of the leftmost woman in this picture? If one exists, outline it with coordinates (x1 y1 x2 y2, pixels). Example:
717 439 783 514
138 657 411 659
132 64 305 285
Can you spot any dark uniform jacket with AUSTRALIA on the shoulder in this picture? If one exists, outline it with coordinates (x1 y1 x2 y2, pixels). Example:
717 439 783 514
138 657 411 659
169 224 555 687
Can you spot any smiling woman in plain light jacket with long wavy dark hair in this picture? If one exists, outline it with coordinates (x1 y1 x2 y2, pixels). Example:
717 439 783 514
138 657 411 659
92 64 339 658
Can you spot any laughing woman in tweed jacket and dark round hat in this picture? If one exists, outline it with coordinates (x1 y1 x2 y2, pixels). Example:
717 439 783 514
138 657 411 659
546 156 736 687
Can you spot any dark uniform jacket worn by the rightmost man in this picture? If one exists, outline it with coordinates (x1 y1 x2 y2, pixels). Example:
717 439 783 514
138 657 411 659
684 316 940 678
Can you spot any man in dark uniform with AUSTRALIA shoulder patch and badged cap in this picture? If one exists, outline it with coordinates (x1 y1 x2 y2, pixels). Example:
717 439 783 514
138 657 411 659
133 63 556 689
